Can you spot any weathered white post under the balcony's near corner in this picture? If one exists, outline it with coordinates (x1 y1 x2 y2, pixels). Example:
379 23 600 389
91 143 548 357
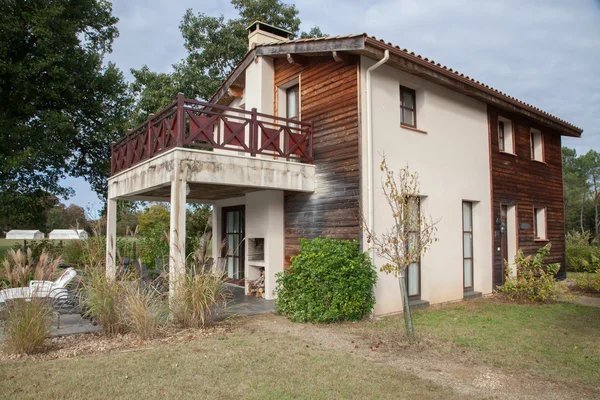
169 165 187 299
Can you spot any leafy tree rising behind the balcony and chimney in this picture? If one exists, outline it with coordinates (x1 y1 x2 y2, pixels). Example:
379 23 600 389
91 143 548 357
131 0 324 123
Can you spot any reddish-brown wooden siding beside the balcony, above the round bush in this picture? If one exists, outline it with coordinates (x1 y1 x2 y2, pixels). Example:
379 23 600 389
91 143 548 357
275 57 360 267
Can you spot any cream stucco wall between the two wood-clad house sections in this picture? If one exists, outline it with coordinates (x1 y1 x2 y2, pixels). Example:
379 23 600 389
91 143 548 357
361 57 492 314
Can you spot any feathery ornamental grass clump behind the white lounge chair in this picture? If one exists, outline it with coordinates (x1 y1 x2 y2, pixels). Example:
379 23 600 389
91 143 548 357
0 248 62 287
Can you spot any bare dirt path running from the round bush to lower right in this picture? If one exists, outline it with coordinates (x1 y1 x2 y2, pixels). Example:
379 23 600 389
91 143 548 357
244 314 600 399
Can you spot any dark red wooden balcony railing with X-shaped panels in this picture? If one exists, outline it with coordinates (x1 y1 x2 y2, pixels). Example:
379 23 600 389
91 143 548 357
111 94 313 175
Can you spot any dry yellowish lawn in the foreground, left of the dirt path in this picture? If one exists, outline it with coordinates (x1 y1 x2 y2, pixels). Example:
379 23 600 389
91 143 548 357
0 332 465 399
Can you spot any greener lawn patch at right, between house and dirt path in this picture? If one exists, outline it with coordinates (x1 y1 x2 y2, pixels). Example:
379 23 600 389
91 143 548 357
368 299 600 387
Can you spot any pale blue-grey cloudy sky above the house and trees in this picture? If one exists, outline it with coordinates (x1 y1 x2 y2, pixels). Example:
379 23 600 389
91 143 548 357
59 0 600 212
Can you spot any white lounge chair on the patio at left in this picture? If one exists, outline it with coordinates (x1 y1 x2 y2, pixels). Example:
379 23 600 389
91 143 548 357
0 268 77 304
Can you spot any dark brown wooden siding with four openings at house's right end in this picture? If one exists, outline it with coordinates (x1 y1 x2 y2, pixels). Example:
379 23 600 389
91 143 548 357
488 107 565 286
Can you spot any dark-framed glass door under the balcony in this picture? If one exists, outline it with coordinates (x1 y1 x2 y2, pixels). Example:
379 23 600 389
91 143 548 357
222 206 246 279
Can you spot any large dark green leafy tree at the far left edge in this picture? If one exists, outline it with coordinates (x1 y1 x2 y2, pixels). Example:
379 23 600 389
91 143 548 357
0 0 131 206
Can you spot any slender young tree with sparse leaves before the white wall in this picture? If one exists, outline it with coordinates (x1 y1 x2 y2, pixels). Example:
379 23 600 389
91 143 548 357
363 156 437 341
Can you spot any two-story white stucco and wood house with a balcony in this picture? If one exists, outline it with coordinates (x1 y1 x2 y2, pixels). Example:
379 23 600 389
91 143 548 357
107 22 582 314
